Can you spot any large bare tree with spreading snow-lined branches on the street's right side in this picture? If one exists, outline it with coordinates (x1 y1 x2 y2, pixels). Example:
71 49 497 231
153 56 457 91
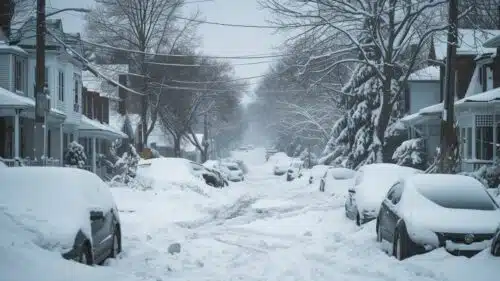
261 0 458 166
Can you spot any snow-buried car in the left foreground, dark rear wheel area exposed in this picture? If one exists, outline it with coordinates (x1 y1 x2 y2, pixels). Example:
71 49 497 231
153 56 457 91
0 167 122 265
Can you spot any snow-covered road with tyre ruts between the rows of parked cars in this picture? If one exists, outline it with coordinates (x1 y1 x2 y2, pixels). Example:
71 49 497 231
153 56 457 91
108 148 500 281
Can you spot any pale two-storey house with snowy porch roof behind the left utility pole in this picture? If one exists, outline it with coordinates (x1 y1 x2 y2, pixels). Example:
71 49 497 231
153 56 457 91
0 19 126 171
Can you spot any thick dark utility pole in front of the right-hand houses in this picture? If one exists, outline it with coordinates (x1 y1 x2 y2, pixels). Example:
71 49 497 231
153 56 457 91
439 0 458 173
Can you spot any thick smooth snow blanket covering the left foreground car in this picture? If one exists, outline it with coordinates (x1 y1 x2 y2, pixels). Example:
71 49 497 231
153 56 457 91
0 167 115 250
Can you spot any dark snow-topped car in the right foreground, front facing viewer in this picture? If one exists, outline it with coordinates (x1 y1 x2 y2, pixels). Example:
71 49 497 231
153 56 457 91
376 174 500 260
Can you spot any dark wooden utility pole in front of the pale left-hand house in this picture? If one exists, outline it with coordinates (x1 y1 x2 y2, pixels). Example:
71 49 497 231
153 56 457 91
33 0 50 165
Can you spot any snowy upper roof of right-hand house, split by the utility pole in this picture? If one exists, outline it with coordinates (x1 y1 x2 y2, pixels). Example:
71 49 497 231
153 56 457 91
434 28 500 60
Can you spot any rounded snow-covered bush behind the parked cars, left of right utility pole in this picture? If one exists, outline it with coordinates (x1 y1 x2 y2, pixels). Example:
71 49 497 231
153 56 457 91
392 138 427 170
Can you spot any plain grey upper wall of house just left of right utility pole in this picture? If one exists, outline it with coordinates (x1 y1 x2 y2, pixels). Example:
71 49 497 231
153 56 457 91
408 81 441 114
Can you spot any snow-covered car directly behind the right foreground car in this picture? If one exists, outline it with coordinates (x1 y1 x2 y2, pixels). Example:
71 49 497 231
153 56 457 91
345 163 422 225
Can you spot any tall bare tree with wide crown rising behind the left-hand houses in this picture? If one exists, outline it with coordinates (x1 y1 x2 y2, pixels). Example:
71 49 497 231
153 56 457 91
87 0 197 149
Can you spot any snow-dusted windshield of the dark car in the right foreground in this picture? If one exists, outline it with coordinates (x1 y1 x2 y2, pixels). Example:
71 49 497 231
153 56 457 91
418 185 498 211
